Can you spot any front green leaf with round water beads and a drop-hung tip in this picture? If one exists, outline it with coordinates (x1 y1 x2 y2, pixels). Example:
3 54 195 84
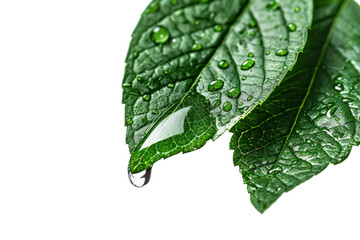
123 0 312 173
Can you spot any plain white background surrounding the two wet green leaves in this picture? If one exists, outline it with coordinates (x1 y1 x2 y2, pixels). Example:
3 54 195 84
0 0 360 240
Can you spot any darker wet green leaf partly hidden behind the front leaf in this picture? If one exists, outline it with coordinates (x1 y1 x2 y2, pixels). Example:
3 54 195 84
230 0 360 212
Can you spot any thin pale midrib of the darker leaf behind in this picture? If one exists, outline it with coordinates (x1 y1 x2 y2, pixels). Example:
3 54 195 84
265 0 350 189
